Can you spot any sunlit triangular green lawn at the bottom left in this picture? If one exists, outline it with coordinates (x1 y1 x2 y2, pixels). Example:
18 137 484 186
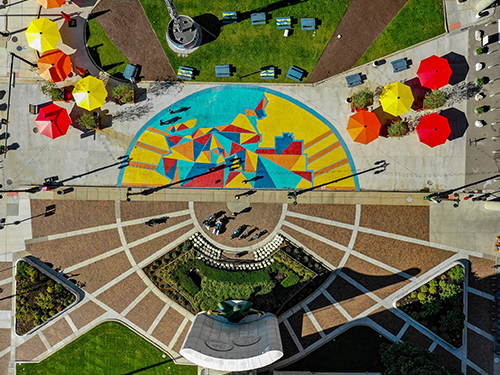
17 322 197 375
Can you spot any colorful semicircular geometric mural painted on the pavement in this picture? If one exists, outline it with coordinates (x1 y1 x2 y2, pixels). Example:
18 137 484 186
118 85 358 190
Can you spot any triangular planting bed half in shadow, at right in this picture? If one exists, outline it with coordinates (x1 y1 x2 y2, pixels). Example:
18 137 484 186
397 265 465 348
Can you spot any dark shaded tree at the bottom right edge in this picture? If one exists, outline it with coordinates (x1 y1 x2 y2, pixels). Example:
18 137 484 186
380 342 451 375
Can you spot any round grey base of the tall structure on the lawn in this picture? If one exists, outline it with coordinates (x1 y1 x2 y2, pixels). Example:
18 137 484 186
167 15 202 54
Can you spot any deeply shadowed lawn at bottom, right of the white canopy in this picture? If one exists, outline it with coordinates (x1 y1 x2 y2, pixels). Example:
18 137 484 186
279 326 390 373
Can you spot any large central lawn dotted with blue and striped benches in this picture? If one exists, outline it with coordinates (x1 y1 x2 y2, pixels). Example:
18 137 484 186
141 0 351 82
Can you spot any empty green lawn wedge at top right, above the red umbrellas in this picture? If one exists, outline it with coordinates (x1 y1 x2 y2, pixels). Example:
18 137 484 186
356 0 445 66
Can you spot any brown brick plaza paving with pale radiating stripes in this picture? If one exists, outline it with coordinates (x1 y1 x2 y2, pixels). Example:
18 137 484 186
0 200 494 374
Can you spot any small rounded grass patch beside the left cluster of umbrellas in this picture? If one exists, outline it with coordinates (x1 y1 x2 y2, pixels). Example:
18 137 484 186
87 19 128 78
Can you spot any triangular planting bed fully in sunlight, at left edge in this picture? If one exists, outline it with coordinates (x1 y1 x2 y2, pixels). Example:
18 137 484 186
16 261 76 335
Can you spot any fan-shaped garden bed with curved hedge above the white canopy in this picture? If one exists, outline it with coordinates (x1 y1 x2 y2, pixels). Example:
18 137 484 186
143 241 329 314
